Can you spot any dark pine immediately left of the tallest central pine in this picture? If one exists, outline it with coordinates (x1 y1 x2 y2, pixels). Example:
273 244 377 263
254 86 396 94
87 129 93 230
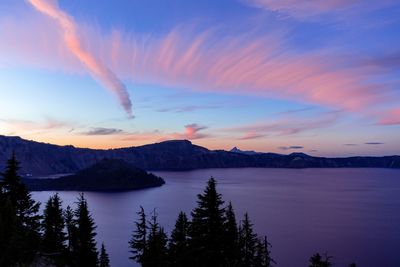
168 212 190 267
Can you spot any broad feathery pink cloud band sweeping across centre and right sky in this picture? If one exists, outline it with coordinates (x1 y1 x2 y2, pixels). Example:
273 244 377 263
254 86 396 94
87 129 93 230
92 27 388 112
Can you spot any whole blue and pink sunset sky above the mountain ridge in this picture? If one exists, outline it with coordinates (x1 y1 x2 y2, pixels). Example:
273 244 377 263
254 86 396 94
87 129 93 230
0 0 400 156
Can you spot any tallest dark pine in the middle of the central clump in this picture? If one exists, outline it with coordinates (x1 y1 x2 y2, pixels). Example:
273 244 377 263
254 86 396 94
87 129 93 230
190 178 225 266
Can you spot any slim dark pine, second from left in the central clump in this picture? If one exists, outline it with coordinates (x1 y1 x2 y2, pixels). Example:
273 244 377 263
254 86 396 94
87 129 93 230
142 210 168 267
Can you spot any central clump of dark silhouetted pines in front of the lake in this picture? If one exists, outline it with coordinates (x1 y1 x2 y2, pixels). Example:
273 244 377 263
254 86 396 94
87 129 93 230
130 178 274 267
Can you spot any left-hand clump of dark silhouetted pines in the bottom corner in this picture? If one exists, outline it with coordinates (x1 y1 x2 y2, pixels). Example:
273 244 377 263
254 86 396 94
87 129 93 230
0 154 109 267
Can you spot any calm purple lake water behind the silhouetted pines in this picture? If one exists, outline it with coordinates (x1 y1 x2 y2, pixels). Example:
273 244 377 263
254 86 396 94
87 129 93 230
33 168 400 267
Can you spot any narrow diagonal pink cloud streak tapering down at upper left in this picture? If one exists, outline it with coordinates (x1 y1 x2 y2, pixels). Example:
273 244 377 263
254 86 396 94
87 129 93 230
29 0 132 116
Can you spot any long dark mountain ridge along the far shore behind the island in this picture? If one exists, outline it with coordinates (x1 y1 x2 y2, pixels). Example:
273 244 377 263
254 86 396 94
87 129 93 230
0 135 400 176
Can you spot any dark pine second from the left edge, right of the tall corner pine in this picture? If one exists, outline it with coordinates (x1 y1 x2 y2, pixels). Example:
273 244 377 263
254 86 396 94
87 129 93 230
42 194 66 258
